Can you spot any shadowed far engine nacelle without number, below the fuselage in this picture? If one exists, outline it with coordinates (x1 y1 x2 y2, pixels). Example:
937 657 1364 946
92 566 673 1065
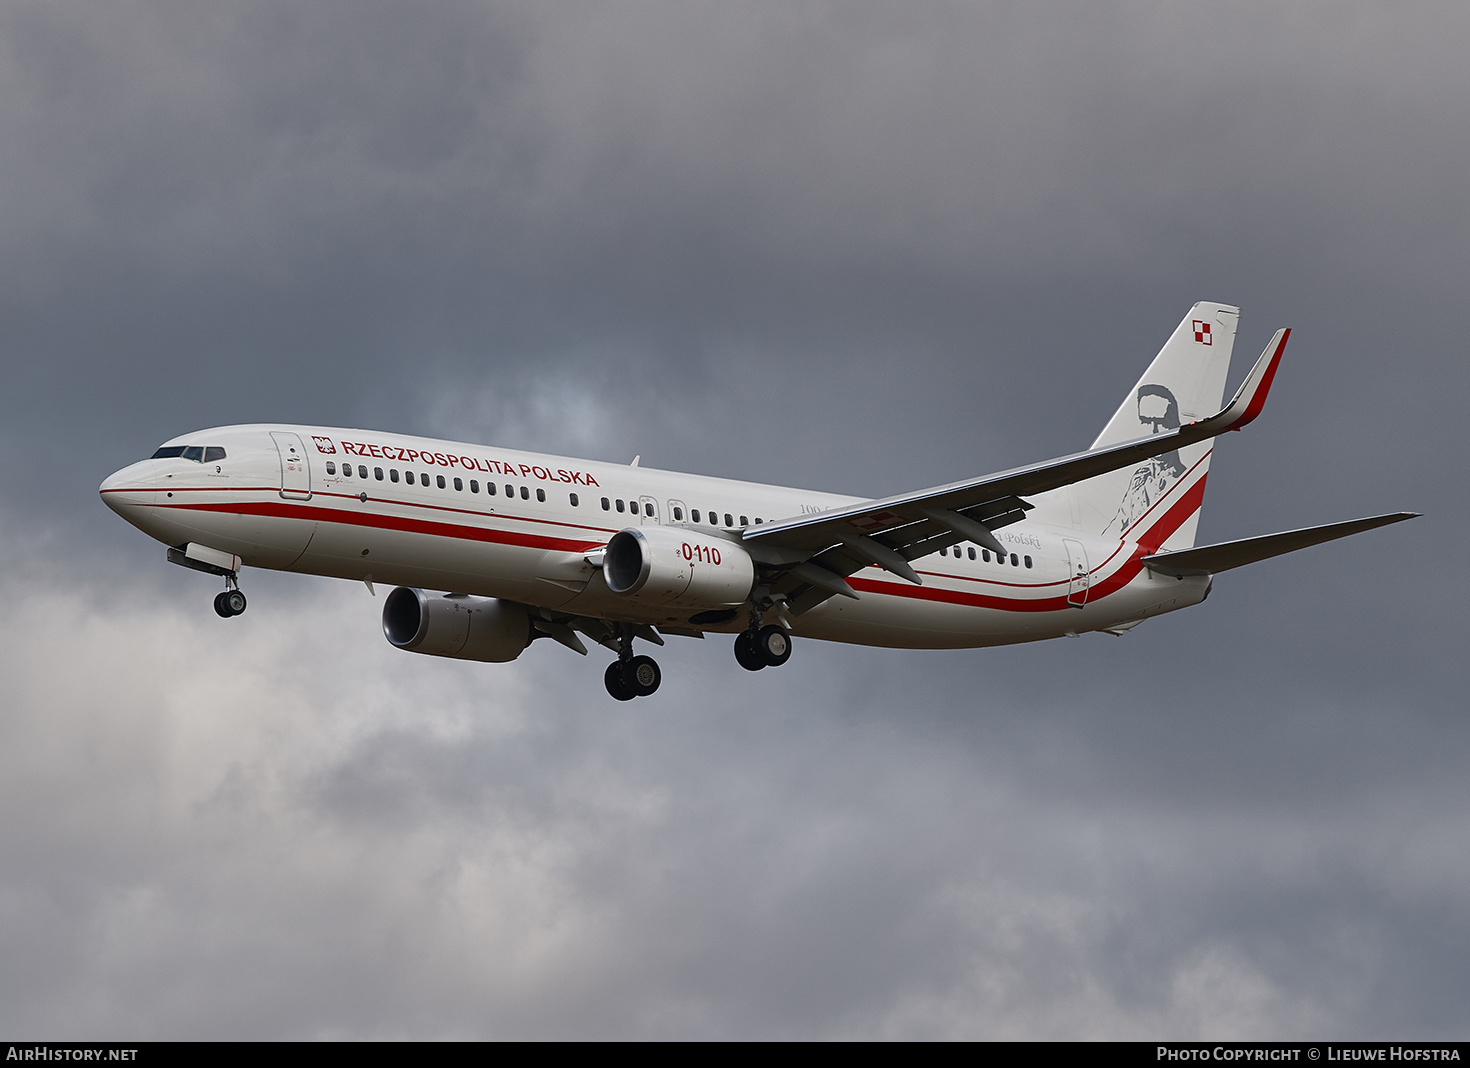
382 586 531 664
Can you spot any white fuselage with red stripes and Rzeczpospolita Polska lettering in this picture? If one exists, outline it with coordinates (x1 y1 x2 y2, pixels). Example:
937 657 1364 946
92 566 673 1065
101 425 1210 648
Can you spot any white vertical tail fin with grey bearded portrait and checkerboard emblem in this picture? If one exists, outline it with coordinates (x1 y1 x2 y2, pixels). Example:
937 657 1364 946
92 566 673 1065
1033 301 1241 551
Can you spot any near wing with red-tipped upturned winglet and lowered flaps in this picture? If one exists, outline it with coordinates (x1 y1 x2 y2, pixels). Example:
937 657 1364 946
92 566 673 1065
742 331 1291 614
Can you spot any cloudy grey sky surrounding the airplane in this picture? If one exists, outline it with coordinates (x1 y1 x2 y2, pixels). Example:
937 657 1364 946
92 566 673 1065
0 0 1470 1039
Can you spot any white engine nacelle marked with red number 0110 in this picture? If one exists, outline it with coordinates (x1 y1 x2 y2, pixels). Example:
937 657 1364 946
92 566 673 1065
603 526 756 608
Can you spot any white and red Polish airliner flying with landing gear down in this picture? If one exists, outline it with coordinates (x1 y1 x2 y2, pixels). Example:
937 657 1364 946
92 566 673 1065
100 303 1417 701
